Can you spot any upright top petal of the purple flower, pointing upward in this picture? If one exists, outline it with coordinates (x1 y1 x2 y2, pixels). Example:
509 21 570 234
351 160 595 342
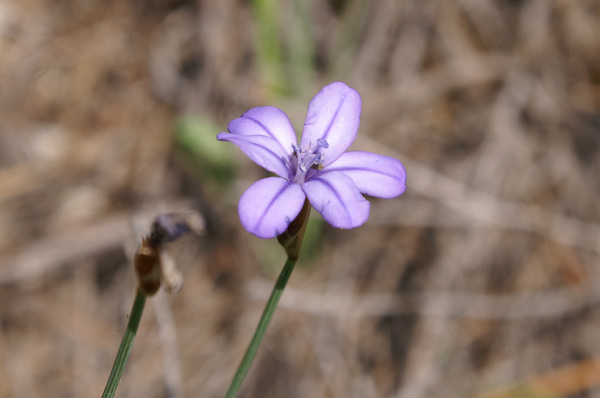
301 82 361 166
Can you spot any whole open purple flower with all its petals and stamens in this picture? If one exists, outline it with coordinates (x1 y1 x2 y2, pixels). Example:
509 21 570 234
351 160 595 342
217 82 406 239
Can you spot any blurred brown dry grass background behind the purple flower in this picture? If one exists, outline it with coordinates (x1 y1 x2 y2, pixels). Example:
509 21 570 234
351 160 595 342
0 0 600 398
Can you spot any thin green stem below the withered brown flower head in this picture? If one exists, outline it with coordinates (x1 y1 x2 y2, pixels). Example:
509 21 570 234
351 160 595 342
102 289 146 398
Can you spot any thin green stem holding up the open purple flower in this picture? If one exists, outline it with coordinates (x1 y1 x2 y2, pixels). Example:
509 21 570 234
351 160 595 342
225 258 297 398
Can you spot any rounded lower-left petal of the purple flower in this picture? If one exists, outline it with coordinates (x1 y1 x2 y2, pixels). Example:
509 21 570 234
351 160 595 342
238 177 306 239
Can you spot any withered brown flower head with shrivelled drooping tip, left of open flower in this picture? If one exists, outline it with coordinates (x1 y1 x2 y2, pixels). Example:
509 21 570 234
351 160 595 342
134 212 204 296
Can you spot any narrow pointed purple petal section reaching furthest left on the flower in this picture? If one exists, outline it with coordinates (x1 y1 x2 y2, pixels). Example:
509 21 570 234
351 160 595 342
217 133 290 178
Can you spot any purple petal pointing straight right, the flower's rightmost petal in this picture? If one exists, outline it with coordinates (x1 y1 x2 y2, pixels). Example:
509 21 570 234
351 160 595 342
320 151 406 199
